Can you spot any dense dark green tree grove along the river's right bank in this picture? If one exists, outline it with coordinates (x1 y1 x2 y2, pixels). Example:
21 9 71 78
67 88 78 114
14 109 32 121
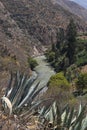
45 19 87 73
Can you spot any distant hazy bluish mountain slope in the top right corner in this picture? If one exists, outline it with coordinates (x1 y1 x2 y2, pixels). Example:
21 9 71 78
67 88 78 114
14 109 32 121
52 0 87 21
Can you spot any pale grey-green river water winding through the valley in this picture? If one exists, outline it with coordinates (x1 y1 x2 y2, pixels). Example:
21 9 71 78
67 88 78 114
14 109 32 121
34 55 55 90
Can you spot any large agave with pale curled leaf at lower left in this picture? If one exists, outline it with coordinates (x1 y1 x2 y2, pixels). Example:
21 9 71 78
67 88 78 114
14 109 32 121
2 72 45 114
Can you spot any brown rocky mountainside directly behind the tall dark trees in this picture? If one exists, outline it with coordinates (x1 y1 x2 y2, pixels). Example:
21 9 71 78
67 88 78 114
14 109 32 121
1 0 86 45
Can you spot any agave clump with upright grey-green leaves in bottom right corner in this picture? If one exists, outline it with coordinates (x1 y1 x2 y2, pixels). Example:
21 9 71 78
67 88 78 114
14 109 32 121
39 102 87 130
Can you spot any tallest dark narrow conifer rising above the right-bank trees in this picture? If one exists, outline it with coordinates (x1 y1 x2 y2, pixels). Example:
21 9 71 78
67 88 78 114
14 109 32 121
66 19 77 64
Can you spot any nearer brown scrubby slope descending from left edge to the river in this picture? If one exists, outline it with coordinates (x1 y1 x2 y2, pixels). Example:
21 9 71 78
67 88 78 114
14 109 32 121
0 2 44 74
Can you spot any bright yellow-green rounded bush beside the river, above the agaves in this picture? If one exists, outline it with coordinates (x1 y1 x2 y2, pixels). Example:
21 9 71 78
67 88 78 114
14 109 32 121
48 72 69 89
